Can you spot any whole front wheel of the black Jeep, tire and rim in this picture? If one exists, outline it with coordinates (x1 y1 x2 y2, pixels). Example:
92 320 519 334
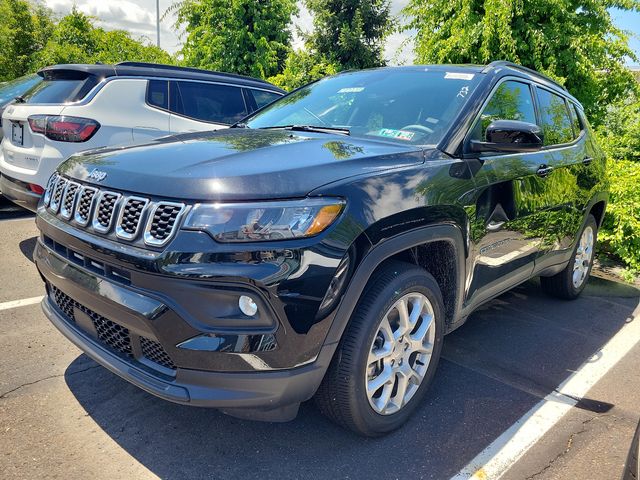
315 261 444 437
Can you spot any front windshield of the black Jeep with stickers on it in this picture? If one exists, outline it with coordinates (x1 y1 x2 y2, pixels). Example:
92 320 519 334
246 67 478 145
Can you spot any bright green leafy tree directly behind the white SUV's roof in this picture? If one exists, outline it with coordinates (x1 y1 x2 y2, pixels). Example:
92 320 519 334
171 0 297 78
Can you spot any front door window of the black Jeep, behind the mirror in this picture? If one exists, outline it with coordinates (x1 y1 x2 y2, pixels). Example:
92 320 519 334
471 80 536 141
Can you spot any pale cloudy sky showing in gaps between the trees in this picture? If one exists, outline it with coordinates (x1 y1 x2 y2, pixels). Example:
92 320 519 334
44 0 640 65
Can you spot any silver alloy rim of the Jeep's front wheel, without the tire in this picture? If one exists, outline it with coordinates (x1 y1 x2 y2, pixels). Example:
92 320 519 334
364 293 436 415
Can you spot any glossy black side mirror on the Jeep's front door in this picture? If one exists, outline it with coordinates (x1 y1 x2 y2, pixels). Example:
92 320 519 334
470 120 543 153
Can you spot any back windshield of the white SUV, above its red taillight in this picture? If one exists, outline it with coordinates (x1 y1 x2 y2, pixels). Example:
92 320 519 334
22 71 98 103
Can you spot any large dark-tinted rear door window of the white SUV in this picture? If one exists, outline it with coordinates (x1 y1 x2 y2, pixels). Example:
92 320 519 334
171 81 248 124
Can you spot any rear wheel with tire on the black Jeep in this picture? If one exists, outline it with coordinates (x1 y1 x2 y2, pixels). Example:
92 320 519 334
540 214 598 300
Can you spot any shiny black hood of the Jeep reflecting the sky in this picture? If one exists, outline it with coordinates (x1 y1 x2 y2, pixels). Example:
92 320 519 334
60 129 424 201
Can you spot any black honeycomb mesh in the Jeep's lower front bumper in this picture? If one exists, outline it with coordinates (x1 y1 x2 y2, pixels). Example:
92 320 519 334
49 285 176 370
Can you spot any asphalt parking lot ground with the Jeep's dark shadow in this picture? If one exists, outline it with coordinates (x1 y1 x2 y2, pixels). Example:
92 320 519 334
0 200 640 479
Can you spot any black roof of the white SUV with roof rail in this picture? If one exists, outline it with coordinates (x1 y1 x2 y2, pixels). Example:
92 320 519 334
38 62 284 93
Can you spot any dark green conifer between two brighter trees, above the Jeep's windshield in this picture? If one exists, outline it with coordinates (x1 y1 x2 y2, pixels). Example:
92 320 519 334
306 0 392 69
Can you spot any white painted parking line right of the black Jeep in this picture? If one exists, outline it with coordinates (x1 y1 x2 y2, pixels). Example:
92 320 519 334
451 307 640 480
